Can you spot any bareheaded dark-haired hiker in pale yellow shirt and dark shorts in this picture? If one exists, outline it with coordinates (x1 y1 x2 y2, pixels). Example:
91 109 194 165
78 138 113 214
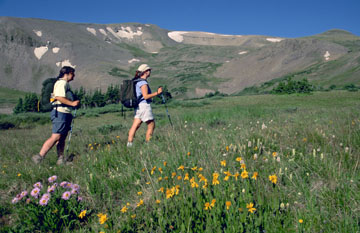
32 66 80 165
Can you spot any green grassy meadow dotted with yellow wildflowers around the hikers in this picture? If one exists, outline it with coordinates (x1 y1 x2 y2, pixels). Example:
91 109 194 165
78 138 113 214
0 91 360 232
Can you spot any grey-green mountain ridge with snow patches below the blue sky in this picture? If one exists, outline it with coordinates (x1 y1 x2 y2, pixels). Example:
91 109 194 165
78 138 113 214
0 17 360 97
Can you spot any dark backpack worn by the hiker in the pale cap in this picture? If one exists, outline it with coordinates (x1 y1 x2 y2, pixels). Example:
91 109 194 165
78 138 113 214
120 78 143 108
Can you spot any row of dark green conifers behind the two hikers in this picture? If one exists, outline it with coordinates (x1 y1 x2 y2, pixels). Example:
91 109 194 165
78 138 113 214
13 85 172 114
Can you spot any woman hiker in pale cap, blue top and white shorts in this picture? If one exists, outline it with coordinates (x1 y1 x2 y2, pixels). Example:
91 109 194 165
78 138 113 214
127 64 163 147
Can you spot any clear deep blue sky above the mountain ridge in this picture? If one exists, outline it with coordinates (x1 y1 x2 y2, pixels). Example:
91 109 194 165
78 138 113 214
0 0 360 38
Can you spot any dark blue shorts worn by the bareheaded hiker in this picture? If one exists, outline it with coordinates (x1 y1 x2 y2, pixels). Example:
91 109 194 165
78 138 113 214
50 110 72 135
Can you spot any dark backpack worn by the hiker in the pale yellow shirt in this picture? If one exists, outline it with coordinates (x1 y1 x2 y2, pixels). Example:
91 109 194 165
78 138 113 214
40 78 77 112
